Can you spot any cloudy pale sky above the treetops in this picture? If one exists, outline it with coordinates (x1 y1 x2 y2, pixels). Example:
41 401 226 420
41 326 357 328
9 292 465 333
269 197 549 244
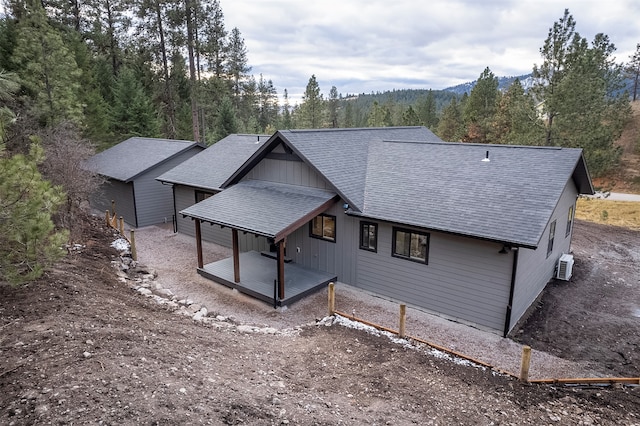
219 0 640 105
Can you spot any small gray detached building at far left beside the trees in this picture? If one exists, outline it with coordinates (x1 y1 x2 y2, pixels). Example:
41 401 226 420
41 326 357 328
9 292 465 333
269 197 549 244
84 137 204 227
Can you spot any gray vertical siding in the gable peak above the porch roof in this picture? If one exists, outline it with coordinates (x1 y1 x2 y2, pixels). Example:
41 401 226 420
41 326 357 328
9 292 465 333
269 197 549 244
243 158 331 189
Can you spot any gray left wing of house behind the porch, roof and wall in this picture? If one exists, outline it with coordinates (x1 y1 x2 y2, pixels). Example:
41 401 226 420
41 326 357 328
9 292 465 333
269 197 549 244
156 134 270 247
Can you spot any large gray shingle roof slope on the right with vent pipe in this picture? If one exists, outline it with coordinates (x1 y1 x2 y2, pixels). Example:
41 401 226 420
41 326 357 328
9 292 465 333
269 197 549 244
361 142 592 247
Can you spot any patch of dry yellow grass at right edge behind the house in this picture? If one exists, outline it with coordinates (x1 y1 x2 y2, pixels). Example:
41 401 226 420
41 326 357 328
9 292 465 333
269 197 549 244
576 198 640 230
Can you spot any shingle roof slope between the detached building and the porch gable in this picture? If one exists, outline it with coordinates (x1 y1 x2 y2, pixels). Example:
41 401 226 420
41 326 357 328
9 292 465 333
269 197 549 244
157 134 269 190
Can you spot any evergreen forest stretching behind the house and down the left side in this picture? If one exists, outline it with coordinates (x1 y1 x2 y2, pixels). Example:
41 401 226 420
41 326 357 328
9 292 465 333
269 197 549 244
0 0 640 282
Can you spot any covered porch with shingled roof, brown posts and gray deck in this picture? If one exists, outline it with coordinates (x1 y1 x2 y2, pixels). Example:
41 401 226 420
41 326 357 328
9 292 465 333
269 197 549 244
181 181 339 307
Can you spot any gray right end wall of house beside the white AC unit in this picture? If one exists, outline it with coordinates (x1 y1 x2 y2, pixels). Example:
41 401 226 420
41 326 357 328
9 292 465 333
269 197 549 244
509 180 578 330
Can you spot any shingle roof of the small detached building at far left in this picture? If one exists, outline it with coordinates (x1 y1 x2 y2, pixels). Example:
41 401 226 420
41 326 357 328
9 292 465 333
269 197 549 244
85 137 204 182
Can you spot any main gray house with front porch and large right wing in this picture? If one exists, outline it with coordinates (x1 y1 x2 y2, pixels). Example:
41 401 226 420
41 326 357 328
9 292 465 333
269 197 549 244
179 127 593 336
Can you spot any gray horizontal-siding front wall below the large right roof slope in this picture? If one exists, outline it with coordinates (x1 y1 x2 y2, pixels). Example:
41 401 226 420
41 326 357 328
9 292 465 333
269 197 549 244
355 221 513 331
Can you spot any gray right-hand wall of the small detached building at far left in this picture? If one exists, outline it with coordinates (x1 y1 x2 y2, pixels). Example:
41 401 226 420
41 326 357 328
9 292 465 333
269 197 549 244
134 149 200 227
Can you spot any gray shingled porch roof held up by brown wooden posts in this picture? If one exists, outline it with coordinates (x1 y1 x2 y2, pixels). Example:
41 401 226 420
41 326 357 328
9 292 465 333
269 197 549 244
180 180 339 241
